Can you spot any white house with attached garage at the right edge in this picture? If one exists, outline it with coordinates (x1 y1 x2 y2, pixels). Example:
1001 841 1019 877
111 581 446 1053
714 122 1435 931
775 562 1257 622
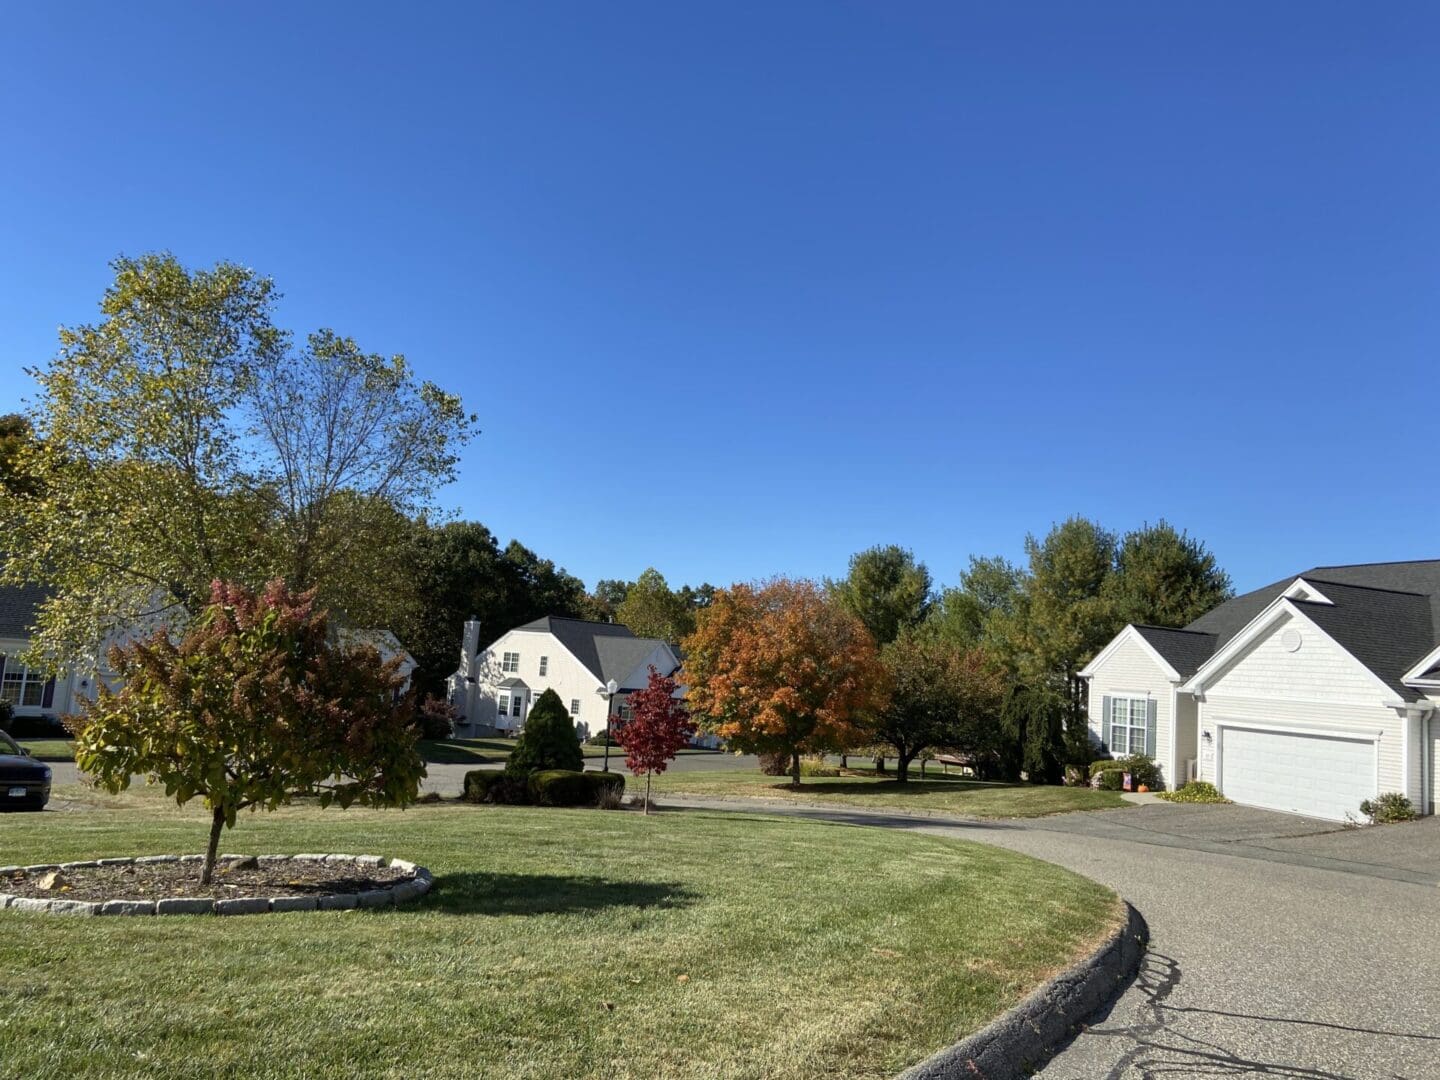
1080 560 1440 821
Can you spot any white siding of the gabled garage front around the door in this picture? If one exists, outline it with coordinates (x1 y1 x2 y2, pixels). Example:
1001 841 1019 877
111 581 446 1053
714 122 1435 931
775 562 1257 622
1200 618 1420 814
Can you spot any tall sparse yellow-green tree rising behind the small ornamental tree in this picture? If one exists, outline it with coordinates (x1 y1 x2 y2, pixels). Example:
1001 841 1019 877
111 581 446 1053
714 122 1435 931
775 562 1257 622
0 255 474 660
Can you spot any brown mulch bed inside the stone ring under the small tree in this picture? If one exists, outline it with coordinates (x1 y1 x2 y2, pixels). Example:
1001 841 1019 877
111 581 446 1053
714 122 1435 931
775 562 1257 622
0 860 415 901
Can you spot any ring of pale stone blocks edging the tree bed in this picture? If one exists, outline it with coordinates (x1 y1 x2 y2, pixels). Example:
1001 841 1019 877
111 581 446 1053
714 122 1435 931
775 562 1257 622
0 854 435 916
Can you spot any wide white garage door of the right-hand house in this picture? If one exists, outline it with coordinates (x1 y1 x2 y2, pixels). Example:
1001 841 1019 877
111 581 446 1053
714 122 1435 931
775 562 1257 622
1220 727 1375 821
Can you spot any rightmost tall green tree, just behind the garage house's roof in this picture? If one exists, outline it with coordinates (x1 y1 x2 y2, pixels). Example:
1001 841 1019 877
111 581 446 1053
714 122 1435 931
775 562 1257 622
1103 521 1234 629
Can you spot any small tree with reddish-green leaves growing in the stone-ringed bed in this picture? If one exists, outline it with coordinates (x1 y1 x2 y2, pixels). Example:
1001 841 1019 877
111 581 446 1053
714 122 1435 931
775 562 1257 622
68 582 425 884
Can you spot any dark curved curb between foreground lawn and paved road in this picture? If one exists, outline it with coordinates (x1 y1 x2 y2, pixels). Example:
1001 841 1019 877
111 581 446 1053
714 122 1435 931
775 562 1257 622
900 903 1149 1080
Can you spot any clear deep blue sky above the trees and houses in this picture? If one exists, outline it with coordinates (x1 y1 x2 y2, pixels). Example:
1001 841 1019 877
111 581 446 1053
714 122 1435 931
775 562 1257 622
0 0 1440 588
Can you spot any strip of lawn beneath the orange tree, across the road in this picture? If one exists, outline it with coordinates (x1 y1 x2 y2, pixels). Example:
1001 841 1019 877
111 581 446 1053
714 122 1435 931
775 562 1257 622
655 769 1129 818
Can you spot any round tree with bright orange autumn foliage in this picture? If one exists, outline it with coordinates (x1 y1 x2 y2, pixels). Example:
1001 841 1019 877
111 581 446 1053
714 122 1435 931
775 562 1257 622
681 577 886 785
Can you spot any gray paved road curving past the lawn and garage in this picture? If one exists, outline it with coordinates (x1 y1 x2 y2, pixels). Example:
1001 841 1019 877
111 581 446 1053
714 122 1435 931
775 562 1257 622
665 798 1440 1080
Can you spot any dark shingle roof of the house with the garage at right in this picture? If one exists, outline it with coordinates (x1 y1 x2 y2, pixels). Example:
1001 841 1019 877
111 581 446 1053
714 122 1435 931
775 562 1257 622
1169 559 1440 700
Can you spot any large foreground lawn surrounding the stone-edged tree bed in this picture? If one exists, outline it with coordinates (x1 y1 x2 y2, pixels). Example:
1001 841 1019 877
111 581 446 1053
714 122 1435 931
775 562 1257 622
0 791 1119 1080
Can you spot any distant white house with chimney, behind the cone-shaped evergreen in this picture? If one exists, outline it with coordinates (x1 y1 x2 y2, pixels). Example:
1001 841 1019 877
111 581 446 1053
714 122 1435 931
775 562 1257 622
449 615 680 734
